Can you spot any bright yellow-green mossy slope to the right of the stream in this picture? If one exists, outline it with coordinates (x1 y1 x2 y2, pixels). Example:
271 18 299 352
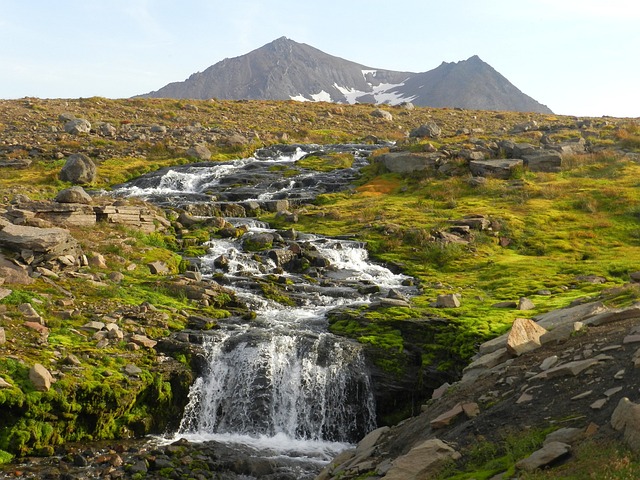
264 152 640 371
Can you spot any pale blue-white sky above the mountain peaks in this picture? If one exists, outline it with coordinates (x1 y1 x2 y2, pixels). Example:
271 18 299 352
0 0 640 117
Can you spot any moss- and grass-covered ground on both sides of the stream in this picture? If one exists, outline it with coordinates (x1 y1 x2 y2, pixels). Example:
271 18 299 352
0 98 640 470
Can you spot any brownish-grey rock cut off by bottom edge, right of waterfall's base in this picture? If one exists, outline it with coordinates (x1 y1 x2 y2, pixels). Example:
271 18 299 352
384 438 461 480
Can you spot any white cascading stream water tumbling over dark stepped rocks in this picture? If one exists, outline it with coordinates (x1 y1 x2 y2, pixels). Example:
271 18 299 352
115 144 410 470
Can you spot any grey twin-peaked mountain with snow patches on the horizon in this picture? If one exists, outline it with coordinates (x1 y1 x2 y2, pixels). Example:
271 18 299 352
140 37 552 113
